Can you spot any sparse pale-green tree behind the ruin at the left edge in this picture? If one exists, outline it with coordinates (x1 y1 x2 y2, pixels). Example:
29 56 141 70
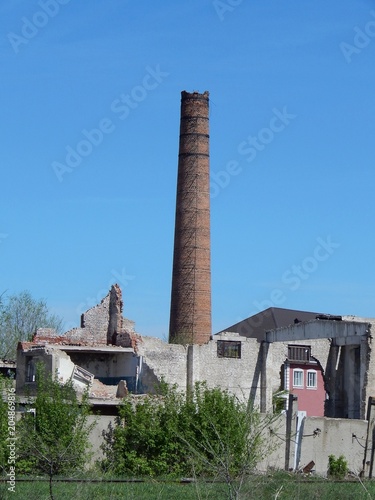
0 291 63 359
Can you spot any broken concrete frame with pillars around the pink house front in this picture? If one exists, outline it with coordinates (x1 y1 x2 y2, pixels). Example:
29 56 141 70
262 316 375 419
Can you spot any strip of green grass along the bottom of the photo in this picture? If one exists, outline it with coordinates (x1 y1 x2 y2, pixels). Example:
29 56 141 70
0 473 375 500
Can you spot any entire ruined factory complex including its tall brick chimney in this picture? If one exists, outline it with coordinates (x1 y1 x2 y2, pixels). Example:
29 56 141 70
12 92 375 473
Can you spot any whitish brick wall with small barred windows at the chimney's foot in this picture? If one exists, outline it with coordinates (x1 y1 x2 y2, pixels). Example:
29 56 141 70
138 332 342 413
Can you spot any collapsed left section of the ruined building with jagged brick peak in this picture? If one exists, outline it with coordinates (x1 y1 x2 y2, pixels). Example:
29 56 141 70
16 285 141 405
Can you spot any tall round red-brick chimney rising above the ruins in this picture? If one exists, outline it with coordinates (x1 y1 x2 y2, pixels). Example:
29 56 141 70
169 91 211 344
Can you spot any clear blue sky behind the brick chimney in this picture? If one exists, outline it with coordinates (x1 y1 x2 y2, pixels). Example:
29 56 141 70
0 0 375 338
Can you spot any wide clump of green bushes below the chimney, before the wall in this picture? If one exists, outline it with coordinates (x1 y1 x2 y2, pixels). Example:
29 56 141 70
103 384 276 498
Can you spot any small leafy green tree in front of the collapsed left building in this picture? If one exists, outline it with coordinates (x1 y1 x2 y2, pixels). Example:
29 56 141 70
17 363 95 498
